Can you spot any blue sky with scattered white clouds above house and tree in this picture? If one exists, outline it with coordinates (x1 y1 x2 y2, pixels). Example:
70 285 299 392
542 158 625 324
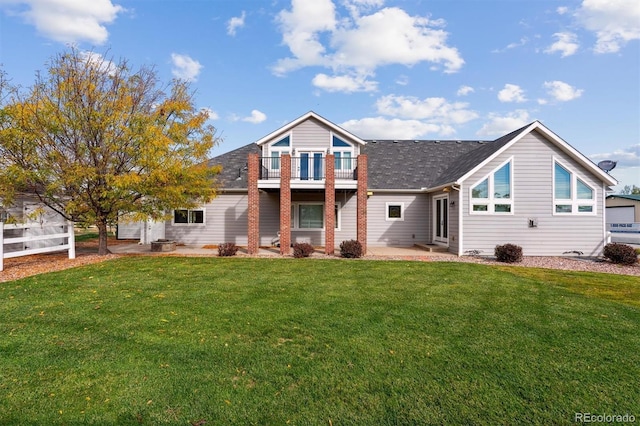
0 0 640 188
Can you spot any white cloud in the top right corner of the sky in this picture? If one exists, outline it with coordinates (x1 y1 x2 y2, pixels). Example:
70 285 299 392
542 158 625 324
575 0 640 53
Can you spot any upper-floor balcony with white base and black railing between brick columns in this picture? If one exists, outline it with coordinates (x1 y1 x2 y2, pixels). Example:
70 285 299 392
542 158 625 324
258 153 358 189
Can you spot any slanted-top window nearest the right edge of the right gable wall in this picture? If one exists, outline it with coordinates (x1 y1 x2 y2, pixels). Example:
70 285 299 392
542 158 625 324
553 160 596 215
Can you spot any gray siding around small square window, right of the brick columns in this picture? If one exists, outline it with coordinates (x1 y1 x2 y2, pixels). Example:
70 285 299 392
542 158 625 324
367 191 431 247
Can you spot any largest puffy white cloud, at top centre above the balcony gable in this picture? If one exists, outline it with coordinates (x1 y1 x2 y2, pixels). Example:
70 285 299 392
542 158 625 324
272 0 464 89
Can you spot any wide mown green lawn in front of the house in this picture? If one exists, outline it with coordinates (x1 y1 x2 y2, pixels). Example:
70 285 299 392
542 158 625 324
0 257 640 425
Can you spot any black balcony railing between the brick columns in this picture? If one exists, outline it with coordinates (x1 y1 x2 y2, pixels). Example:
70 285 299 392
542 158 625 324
260 154 358 181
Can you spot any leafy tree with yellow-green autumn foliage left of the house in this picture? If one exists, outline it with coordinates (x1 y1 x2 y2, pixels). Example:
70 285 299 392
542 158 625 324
0 48 219 255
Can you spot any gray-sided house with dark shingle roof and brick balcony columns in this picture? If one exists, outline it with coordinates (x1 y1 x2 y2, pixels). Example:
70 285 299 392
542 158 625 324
136 112 616 256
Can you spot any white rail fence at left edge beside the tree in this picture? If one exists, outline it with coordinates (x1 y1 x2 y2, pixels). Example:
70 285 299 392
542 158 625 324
0 222 76 271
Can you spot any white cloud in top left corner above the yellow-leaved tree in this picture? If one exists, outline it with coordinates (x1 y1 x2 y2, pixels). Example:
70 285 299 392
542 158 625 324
0 0 125 45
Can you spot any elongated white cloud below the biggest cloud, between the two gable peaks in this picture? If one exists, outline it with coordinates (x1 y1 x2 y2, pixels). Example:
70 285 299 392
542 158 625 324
376 95 478 125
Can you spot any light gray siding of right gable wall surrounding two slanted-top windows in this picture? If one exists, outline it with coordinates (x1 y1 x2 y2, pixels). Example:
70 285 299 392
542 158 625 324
461 132 604 256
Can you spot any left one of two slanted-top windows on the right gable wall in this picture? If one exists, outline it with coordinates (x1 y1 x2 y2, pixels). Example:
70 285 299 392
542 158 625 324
471 159 513 214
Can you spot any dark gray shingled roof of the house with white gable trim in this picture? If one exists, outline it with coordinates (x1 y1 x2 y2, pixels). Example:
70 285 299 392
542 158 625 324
209 116 617 190
